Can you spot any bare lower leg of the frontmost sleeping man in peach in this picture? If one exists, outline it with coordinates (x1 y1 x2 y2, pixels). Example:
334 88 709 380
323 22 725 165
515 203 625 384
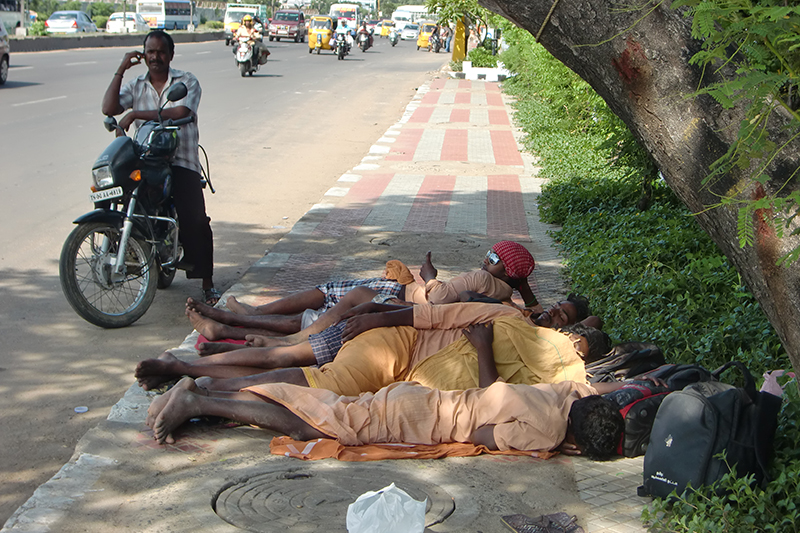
151 378 329 444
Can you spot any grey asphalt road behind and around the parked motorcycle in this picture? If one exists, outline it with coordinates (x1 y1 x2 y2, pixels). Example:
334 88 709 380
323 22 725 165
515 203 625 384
0 35 448 524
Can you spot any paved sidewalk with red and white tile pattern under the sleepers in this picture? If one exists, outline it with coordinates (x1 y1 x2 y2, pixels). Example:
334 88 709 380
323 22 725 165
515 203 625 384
2 71 647 533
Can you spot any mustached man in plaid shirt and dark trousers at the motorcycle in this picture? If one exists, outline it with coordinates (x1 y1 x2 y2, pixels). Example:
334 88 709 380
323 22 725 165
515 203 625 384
102 30 221 305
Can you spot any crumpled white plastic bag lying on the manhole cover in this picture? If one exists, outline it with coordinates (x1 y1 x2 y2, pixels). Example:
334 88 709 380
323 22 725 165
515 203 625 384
347 483 427 533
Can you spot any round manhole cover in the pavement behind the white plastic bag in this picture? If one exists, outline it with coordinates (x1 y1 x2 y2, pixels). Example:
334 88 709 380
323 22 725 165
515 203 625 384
213 464 455 533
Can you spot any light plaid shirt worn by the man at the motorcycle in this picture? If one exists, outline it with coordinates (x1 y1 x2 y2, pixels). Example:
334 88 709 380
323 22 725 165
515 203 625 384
119 68 202 172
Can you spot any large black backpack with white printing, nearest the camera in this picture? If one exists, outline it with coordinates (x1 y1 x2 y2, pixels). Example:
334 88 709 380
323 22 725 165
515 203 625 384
639 361 781 498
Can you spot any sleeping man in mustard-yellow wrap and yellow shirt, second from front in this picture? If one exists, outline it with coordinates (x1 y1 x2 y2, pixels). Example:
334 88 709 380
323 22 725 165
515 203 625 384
136 303 609 395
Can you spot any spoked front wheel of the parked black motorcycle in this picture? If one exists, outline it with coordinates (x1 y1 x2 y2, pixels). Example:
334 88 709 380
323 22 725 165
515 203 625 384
59 222 158 328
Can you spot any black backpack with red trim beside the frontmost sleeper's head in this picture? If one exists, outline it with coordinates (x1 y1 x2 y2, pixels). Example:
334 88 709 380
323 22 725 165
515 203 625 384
603 364 715 457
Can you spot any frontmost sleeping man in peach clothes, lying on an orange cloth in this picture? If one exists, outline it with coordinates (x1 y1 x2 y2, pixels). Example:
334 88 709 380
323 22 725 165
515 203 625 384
146 324 623 459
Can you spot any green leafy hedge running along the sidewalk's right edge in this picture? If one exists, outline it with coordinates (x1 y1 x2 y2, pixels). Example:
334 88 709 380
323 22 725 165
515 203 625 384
500 22 800 533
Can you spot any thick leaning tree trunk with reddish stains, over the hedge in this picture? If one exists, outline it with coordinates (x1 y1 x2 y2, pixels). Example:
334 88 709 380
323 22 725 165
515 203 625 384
479 0 800 371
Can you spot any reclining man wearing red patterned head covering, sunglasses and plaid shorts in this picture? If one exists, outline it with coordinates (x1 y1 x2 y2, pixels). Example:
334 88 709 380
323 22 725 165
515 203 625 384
186 241 542 341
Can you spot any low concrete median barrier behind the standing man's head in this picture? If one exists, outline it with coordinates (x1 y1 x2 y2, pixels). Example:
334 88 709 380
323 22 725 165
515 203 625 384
9 30 225 54
